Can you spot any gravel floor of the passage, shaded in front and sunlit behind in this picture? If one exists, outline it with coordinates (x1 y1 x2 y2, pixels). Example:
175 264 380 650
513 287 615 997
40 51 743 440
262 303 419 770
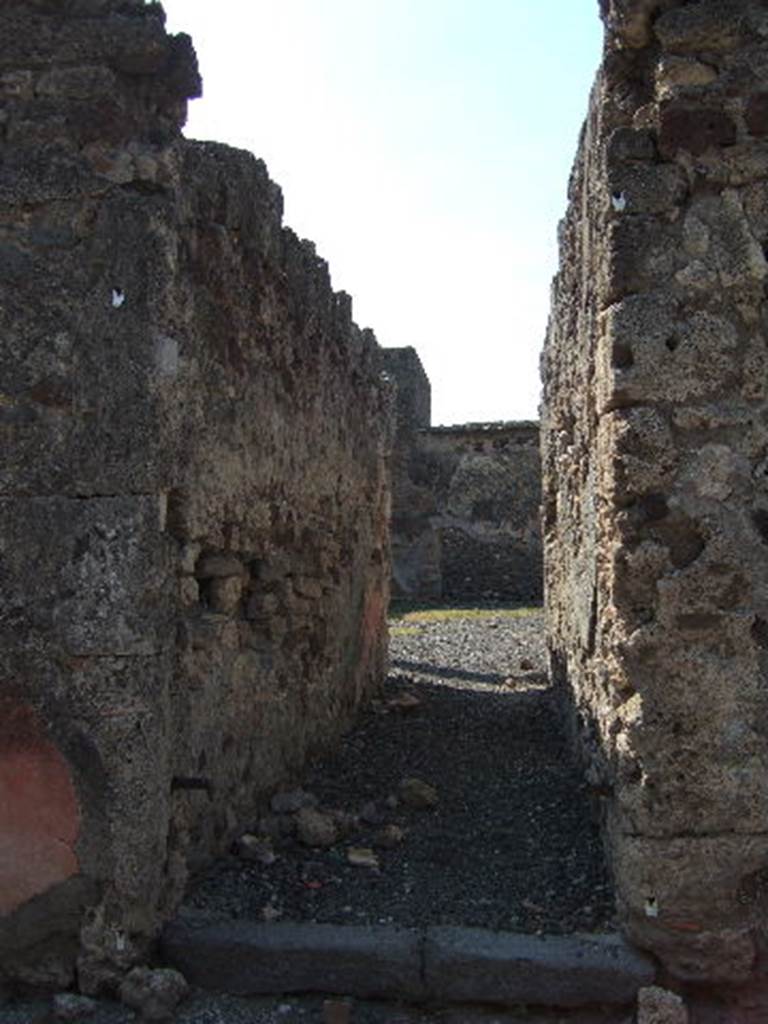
186 609 612 934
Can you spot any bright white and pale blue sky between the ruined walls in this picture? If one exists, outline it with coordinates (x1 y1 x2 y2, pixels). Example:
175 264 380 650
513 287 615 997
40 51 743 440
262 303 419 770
164 0 601 424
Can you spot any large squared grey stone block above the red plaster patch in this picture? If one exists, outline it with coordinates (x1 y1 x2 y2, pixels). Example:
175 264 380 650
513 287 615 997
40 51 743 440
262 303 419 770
0 495 173 656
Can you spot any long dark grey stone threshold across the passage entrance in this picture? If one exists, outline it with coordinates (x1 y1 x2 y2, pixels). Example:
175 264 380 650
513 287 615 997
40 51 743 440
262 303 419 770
162 916 655 1009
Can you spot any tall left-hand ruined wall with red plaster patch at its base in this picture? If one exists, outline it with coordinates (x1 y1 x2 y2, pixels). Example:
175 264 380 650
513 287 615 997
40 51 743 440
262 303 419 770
0 0 391 991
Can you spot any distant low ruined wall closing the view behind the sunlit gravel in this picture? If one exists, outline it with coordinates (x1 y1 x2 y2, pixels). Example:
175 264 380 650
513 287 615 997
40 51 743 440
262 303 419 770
382 348 542 601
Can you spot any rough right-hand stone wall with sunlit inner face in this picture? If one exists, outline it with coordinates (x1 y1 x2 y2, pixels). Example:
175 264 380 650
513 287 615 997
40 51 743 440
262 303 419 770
542 0 768 995
